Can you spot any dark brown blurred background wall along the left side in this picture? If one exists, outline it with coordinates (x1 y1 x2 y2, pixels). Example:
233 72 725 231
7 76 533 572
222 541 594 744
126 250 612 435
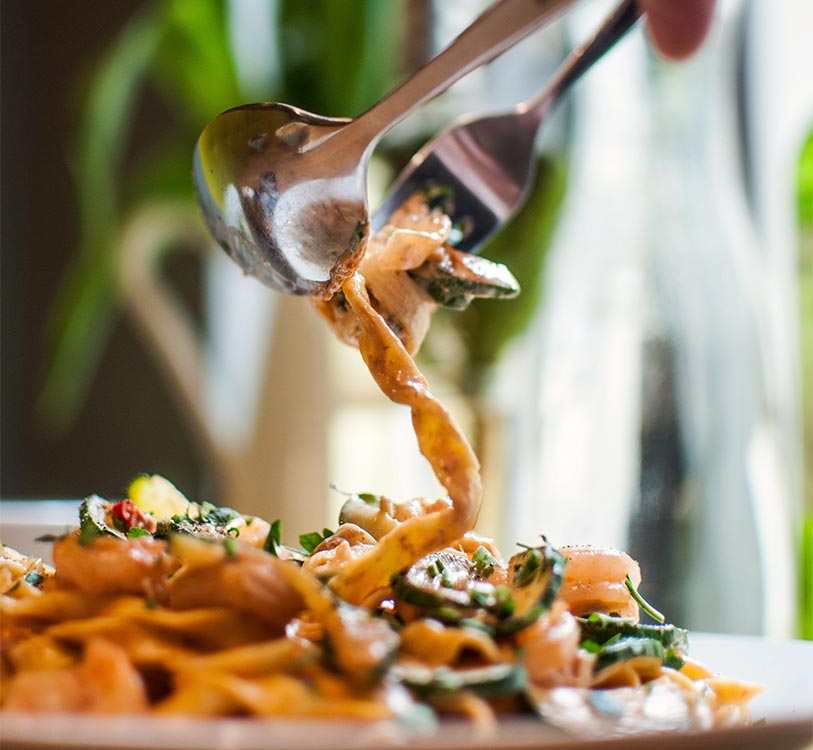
0 0 205 506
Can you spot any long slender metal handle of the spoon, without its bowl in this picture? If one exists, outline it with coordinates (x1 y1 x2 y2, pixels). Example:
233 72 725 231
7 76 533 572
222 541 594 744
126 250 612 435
346 0 574 150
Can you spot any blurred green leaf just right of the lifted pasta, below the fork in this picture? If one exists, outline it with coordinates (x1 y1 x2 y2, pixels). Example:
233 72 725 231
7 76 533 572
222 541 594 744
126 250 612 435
443 155 567 395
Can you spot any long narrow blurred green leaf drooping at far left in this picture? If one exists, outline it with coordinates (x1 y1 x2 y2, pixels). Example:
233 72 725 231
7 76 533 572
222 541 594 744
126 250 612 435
39 9 164 428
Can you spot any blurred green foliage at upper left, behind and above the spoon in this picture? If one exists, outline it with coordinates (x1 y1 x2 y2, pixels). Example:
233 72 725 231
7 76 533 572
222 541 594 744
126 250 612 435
40 0 405 428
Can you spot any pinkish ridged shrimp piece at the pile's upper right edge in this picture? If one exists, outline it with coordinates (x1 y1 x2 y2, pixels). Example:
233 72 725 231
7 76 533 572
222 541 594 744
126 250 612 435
559 546 641 622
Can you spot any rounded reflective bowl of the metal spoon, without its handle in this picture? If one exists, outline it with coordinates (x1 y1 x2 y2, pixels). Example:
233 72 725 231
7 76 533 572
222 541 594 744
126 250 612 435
194 104 367 297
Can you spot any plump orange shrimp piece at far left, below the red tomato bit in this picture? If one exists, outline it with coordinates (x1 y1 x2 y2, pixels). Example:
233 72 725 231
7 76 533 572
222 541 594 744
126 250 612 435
53 534 171 595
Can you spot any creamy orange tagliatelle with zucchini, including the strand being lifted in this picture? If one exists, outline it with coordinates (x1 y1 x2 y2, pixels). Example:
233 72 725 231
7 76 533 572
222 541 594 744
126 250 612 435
0 198 758 734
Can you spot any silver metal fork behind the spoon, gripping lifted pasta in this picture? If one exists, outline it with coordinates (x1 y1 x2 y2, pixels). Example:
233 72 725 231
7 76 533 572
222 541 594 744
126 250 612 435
372 0 641 253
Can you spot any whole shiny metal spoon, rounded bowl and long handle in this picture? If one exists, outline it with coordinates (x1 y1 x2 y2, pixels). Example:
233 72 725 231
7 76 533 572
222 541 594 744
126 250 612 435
194 0 574 296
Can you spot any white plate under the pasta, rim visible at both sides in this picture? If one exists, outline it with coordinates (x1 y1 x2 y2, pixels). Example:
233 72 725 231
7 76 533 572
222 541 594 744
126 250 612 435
0 503 813 750
